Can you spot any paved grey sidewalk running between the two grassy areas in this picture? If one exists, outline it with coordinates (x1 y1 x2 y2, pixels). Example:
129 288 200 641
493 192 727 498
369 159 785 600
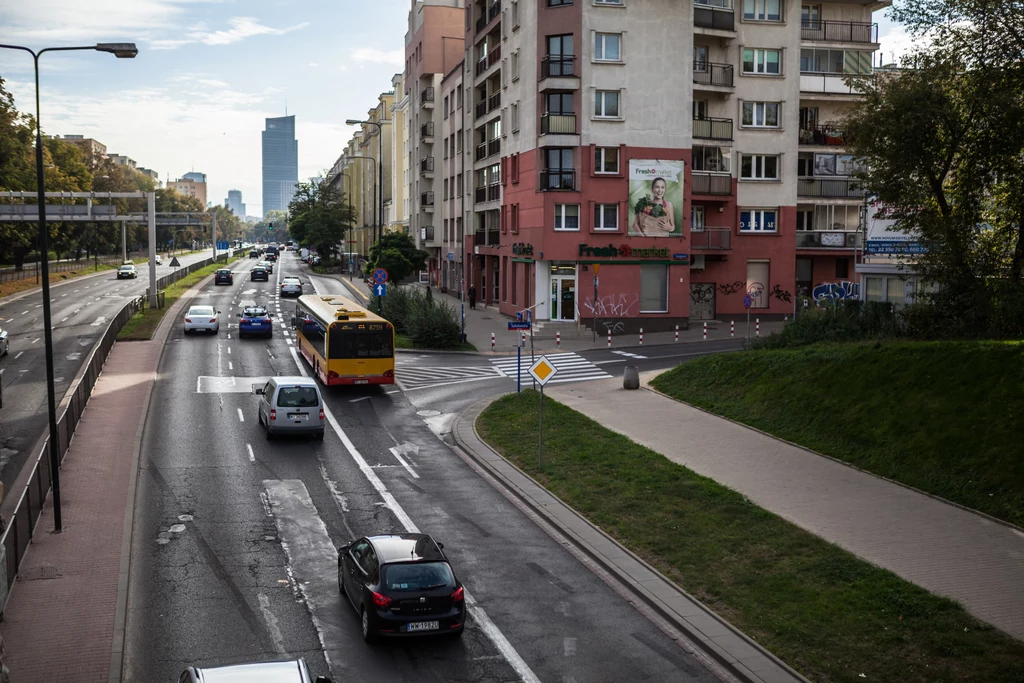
547 373 1024 640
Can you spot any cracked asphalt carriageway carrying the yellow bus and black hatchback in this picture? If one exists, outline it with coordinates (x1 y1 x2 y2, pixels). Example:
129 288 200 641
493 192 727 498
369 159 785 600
125 253 717 682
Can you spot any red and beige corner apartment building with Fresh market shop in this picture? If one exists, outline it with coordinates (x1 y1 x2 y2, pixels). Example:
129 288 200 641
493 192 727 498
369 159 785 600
454 0 889 331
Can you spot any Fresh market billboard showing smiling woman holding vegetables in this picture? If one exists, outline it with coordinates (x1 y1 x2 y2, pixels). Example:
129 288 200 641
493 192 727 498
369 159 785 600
629 159 683 238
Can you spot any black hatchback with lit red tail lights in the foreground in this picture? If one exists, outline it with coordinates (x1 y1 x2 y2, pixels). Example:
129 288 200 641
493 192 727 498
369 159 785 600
338 533 466 642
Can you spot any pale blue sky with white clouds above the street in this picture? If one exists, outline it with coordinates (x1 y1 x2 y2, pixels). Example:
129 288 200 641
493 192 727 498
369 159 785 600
0 0 909 216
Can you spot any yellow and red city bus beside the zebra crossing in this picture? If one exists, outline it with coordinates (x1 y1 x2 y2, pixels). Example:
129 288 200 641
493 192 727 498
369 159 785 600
293 295 394 386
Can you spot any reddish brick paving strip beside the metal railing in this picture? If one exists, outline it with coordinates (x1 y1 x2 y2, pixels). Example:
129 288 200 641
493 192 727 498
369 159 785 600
0 342 161 683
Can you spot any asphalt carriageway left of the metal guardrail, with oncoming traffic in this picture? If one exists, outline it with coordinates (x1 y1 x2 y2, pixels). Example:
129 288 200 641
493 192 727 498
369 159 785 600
0 252 210 487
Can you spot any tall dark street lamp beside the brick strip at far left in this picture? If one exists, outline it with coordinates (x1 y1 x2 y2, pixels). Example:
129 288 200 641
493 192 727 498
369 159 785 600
0 43 138 531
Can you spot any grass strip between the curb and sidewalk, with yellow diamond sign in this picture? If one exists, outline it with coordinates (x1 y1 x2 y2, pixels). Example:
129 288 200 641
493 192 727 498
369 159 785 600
476 393 1024 683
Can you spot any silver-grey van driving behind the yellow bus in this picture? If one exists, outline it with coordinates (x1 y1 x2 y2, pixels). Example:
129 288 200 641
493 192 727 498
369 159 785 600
253 376 326 440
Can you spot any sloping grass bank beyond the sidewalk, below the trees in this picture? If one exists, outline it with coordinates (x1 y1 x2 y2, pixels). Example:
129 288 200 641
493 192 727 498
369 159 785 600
653 342 1024 525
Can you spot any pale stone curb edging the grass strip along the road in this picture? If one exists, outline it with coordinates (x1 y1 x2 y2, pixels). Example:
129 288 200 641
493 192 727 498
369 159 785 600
452 395 809 683
